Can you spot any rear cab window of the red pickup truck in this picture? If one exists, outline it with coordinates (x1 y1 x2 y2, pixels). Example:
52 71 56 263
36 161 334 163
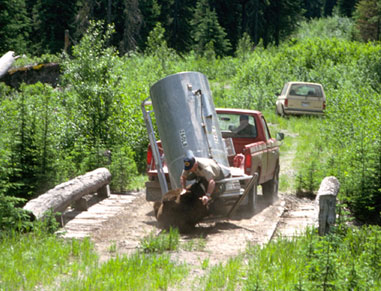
218 113 258 138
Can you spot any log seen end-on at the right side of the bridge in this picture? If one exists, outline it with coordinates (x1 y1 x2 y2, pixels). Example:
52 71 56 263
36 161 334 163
316 176 340 235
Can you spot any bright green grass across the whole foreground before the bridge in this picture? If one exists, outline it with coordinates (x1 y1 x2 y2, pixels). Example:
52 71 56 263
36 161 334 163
0 226 381 291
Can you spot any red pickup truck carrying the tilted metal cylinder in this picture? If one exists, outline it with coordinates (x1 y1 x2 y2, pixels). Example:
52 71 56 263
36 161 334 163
146 108 283 207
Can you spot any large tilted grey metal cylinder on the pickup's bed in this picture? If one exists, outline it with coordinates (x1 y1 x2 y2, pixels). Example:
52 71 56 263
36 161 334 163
150 72 229 188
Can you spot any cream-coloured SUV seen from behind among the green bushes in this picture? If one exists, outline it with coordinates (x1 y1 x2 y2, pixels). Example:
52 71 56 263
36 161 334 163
276 82 326 116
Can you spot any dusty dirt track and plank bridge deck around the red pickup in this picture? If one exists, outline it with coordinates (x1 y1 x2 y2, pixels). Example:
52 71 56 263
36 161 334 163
61 133 316 271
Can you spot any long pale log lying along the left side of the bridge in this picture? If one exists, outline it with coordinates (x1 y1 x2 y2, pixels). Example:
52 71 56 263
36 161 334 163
24 168 111 219
